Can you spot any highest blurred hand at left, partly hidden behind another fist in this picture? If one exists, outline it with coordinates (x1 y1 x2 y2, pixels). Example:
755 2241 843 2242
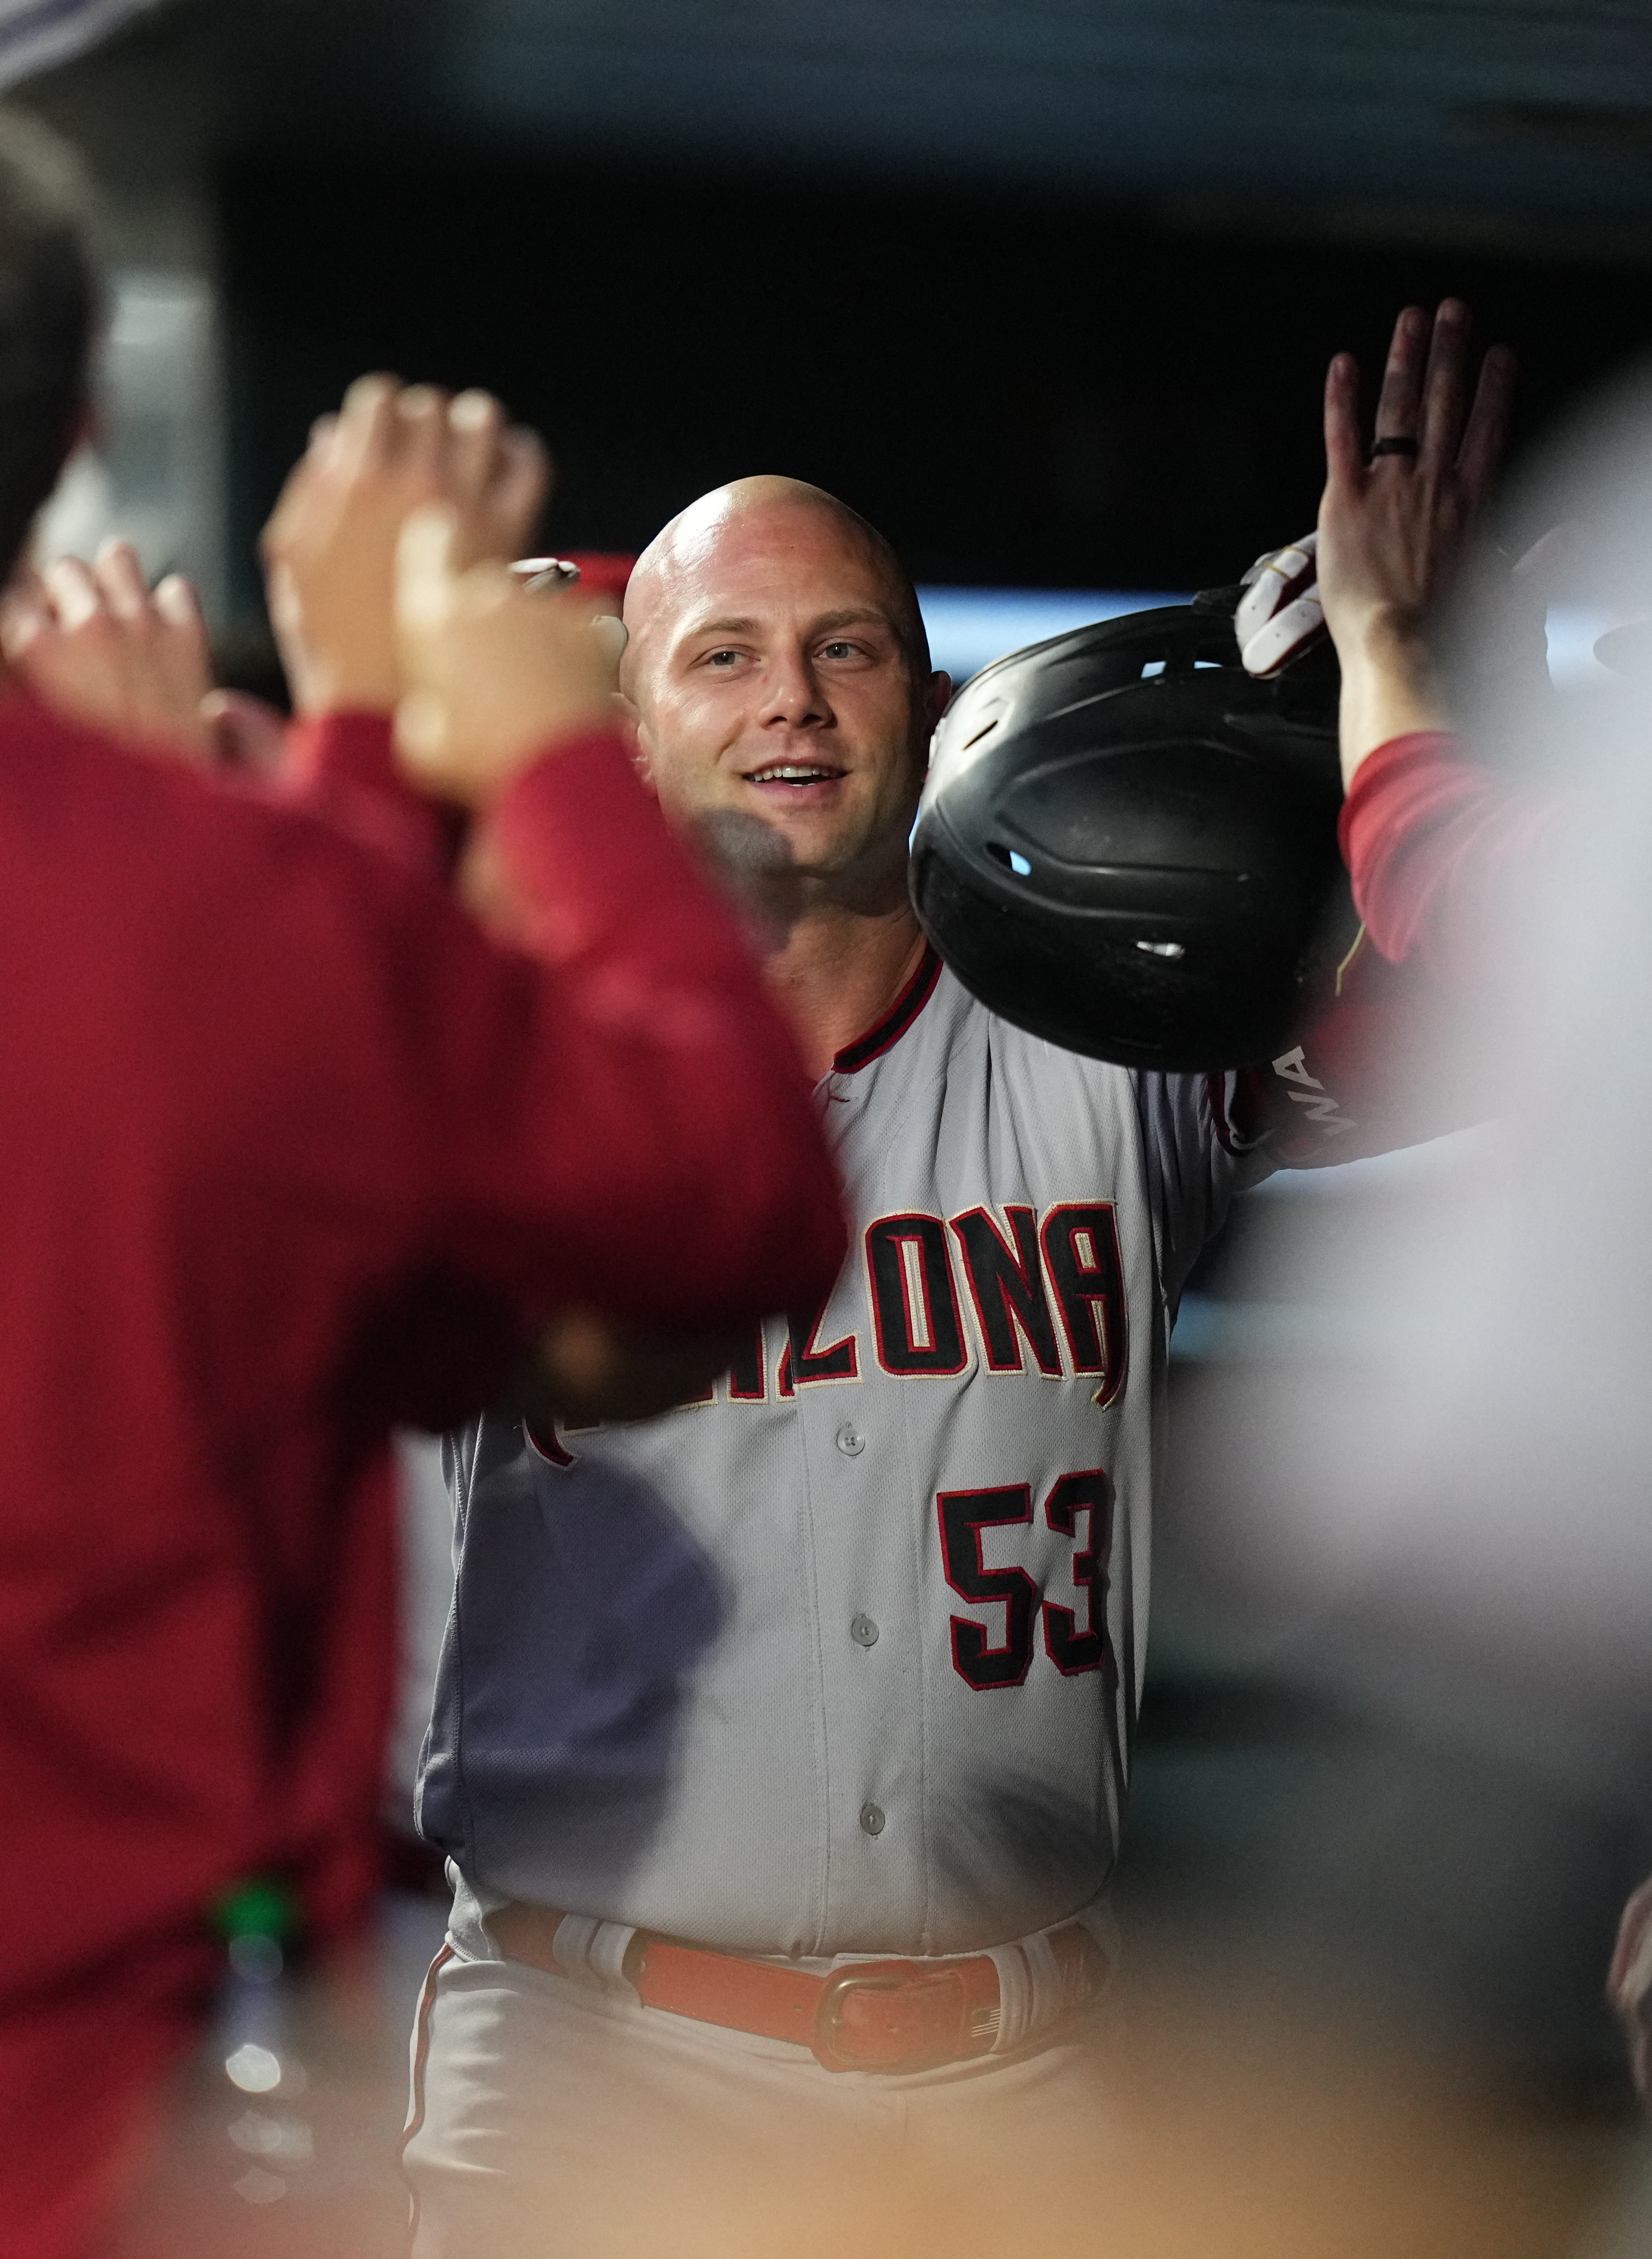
262 377 549 714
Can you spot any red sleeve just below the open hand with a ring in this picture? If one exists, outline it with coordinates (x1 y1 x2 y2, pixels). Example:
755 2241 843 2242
1340 732 1580 985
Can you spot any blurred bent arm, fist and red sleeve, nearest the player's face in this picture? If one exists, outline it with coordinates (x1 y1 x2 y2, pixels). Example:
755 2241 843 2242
375 508 845 1414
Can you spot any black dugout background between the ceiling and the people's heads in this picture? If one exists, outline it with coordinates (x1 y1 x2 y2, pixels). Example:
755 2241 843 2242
222 145 1652 597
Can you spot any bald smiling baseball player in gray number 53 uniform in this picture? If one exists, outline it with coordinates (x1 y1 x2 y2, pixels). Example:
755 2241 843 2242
405 477 1464 2259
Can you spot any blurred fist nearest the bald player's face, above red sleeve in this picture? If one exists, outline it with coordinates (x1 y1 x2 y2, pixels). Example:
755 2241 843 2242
396 508 624 809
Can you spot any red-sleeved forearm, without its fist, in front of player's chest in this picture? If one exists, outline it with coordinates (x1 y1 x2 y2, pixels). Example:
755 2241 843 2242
472 734 845 1331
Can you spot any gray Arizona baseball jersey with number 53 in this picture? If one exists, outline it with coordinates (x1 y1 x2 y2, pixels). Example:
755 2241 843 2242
420 958 1347 1954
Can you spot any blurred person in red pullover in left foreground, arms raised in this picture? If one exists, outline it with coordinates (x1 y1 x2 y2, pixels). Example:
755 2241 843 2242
0 127 843 2259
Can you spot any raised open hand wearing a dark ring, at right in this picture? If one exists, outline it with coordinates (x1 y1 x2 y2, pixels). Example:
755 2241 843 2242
1318 298 1514 779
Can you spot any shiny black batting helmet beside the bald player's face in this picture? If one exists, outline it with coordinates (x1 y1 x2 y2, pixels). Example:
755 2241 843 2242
911 589 1358 1073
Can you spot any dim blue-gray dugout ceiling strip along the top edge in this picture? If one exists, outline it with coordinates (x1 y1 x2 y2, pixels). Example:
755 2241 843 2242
97 0 1652 252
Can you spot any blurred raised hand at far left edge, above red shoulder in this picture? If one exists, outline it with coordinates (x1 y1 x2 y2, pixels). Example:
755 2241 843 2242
0 542 217 768
